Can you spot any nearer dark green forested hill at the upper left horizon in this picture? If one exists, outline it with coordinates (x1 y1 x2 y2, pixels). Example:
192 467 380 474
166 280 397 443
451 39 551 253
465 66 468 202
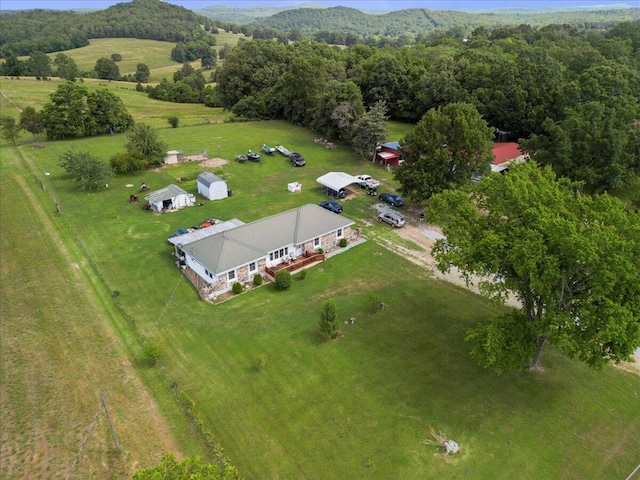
0 0 212 57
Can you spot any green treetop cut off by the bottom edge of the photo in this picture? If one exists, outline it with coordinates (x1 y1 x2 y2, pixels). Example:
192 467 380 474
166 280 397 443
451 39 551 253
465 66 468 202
133 454 238 480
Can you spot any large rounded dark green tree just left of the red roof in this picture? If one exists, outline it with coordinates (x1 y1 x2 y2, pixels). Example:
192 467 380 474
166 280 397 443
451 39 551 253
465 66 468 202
394 103 494 202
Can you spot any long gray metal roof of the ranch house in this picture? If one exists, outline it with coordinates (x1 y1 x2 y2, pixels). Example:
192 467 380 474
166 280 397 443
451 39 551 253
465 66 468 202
182 204 355 274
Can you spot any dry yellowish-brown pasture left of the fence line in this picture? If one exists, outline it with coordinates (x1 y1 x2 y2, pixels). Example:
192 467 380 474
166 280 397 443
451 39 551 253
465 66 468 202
0 147 201 479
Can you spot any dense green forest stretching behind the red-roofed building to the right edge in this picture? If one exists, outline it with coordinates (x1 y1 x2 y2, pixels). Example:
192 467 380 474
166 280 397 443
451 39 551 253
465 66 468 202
215 22 640 190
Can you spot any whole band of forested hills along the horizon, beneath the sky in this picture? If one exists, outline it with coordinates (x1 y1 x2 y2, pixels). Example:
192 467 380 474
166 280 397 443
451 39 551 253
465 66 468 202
0 0 640 60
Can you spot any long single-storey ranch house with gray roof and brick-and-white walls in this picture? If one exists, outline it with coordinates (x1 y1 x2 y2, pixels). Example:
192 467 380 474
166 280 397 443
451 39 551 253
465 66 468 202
169 204 358 300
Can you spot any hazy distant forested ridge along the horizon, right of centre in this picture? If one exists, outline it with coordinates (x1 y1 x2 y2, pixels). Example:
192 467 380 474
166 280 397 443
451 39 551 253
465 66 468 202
252 7 640 37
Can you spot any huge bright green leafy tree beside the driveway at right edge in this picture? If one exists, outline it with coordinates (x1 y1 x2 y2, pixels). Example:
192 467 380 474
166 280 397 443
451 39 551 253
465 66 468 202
427 162 640 371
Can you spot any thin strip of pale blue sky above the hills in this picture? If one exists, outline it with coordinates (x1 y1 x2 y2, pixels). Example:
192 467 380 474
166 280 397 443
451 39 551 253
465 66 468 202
0 0 640 10
